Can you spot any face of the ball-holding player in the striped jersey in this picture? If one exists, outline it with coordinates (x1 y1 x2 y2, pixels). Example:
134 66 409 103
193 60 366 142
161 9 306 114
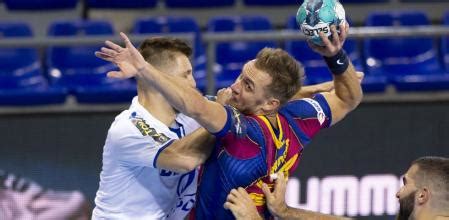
229 60 271 115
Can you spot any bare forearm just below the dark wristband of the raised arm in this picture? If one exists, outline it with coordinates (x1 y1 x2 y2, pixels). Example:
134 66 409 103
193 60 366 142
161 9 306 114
334 63 363 110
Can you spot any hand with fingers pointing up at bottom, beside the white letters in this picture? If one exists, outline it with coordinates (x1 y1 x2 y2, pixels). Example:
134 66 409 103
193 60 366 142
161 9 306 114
262 172 288 218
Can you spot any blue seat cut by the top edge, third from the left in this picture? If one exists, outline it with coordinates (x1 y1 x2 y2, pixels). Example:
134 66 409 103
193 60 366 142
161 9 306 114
165 0 235 8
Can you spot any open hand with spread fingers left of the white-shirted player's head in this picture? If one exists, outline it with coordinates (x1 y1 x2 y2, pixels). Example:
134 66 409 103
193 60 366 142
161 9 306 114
95 32 147 79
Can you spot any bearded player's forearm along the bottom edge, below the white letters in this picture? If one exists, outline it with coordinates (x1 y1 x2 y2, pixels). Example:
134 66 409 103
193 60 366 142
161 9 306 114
277 207 350 220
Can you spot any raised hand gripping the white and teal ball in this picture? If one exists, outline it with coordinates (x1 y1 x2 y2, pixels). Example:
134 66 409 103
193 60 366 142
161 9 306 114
307 22 349 57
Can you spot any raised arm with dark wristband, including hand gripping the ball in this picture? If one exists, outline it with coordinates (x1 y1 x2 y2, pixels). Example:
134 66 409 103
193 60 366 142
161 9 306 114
308 23 363 124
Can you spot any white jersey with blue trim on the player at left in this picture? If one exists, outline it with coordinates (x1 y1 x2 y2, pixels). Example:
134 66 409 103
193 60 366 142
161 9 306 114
92 97 200 220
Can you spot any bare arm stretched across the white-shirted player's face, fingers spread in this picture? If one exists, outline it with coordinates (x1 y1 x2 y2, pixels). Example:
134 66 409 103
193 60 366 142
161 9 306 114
95 33 227 132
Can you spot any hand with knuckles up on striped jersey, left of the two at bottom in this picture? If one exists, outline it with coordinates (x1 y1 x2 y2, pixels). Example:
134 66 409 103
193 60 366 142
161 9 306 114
224 187 262 220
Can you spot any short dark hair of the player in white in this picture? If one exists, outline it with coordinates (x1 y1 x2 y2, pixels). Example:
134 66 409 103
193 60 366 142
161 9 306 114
138 37 192 67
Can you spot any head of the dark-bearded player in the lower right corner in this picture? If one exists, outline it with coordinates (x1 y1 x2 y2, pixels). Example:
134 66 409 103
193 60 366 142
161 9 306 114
396 157 449 220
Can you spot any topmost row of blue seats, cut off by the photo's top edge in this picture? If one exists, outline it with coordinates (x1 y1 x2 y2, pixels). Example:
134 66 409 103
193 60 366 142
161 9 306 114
4 0 445 10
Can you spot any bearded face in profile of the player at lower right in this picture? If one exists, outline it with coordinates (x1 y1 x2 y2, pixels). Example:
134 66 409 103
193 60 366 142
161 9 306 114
396 165 418 220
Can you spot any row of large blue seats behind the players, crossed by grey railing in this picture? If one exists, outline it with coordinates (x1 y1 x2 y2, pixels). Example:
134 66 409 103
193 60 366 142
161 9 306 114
0 11 449 105
